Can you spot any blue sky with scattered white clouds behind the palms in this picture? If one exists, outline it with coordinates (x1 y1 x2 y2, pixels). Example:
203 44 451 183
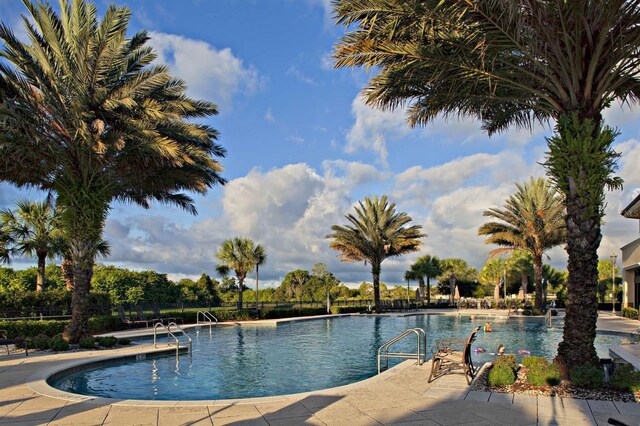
0 0 640 286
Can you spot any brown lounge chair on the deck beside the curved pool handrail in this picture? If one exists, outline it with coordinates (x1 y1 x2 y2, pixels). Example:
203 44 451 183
429 327 480 384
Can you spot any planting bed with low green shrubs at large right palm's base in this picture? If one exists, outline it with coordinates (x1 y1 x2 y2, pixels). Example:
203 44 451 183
472 356 640 402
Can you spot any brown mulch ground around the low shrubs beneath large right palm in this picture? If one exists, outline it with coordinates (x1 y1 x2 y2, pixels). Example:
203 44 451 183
472 367 640 403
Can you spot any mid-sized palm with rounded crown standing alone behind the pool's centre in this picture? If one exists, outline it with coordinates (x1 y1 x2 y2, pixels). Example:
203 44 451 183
327 195 426 310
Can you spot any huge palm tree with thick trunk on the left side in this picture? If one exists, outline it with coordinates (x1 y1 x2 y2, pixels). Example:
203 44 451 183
0 0 224 341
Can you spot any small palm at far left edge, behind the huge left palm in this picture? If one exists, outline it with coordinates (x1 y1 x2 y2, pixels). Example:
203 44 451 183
0 200 64 292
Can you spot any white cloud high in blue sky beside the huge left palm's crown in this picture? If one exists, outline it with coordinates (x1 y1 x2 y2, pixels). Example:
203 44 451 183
150 32 265 111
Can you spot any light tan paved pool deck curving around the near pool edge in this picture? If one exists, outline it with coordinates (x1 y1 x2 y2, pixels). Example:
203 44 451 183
0 310 640 426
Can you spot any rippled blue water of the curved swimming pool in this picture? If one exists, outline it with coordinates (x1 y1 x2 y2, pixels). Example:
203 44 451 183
50 315 621 400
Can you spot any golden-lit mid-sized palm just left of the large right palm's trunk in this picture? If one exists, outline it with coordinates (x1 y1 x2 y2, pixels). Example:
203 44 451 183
478 178 566 309
